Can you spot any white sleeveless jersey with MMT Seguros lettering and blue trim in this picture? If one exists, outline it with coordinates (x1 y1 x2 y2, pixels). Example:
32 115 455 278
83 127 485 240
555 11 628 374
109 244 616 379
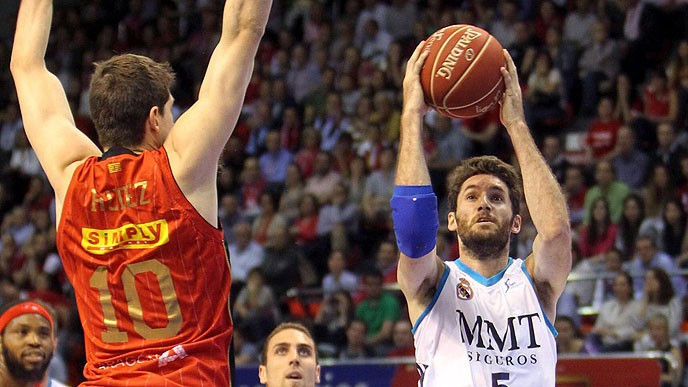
413 258 557 387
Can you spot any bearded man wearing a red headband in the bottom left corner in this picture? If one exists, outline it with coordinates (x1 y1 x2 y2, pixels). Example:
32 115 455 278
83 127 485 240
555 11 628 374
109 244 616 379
0 301 65 387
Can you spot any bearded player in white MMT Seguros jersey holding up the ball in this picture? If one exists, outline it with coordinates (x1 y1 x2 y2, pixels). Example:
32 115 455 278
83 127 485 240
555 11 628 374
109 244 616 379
391 43 571 387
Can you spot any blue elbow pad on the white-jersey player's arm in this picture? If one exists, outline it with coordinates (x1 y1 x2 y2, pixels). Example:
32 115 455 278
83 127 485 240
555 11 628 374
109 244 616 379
390 185 439 258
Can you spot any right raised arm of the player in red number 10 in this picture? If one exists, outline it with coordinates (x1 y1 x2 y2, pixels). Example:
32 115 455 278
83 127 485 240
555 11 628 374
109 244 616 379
164 0 272 197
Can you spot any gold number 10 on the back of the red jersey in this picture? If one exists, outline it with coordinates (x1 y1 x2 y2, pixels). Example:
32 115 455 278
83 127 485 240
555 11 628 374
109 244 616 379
90 259 182 343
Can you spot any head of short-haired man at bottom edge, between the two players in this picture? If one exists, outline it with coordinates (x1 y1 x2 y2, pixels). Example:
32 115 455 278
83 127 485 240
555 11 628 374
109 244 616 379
258 322 320 387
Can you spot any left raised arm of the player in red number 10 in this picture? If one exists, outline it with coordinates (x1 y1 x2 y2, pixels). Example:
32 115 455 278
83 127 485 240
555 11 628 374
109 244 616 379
10 0 100 200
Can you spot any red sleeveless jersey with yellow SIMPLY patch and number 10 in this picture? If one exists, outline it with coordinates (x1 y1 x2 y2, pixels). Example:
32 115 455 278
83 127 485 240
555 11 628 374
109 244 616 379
57 148 232 387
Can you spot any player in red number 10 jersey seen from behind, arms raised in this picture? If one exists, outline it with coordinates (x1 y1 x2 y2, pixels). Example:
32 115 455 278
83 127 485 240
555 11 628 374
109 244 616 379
11 0 271 386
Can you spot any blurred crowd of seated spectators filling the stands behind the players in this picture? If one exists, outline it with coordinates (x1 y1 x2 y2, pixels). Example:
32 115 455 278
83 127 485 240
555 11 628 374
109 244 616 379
0 0 688 383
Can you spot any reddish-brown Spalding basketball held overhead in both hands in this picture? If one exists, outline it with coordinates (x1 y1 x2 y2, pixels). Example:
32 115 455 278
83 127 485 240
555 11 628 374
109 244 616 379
420 24 506 118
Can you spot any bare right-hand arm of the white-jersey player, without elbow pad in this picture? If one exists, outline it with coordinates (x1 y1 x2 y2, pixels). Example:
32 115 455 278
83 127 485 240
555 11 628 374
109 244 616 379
500 50 571 321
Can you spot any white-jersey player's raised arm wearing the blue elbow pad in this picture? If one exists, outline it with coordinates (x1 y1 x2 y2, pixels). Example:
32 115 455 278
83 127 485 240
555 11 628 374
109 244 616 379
392 42 442 323
